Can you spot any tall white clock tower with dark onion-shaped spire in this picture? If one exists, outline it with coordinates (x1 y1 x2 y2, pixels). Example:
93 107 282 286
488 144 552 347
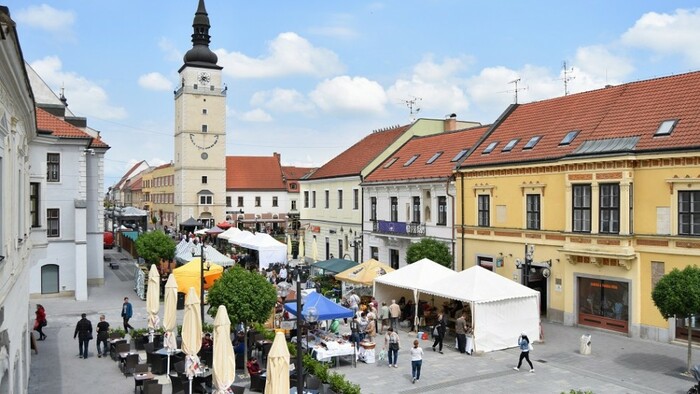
174 0 226 227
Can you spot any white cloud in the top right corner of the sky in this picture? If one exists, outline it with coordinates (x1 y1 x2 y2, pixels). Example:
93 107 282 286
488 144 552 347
622 9 700 67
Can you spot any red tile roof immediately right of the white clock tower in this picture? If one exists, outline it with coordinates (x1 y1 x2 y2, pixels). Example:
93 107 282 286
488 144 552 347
226 156 286 190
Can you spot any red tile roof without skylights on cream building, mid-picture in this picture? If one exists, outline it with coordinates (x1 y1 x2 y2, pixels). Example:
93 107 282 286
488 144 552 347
309 125 411 179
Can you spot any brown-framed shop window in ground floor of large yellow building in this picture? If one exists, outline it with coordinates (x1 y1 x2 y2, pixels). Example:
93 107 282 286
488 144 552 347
578 278 629 332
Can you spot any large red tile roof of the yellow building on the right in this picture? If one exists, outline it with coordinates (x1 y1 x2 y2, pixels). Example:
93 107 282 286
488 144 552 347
462 72 700 167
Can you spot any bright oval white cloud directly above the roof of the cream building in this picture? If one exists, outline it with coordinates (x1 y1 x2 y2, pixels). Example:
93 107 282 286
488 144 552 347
309 75 387 115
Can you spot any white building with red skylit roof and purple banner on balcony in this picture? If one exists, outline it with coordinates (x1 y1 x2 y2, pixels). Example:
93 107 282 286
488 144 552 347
362 127 488 269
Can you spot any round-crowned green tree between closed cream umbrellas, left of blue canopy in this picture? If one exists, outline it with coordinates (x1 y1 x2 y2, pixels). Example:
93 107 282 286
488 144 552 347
207 266 277 374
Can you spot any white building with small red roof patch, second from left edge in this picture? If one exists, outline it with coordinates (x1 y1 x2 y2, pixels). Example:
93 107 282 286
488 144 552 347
27 66 109 300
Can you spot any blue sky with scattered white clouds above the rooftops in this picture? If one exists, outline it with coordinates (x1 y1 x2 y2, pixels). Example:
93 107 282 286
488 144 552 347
3 0 700 185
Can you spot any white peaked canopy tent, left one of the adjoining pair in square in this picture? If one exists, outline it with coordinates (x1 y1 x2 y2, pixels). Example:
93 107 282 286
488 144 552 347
374 259 457 332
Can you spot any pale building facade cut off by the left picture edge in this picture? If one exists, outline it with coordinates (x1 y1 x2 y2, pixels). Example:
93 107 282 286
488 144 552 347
0 6 36 394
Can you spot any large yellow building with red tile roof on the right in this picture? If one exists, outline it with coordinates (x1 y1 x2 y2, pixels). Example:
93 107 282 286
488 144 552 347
455 72 700 341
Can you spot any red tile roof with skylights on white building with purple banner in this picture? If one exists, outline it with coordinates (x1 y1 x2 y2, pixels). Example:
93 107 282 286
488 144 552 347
365 126 489 182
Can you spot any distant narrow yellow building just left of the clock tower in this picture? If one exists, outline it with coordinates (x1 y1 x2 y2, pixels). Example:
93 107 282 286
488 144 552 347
141 163 177 228
